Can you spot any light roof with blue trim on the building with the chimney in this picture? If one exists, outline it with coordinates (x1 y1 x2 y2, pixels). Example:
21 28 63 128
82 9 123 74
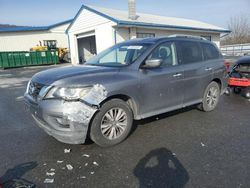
67 5 230 33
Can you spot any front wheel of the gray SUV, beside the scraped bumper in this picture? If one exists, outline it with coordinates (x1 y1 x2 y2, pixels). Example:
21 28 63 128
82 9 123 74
90 99 133 147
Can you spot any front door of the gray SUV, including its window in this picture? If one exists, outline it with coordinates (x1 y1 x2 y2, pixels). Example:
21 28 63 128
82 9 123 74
139 42 183 117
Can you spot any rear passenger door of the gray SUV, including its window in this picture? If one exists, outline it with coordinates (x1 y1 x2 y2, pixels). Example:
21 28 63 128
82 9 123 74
177 40 213 106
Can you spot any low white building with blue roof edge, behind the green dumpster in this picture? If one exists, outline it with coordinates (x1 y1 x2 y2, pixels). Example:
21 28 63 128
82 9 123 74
0 19 72 52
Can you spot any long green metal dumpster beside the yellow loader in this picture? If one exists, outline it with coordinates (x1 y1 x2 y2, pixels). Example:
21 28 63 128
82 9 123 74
0 50 59 68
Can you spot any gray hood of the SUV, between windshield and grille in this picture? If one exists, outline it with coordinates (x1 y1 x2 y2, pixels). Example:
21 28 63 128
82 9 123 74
32 65 118 85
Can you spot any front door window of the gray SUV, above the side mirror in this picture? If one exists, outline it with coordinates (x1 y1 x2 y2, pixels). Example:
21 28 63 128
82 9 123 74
148 42 178 67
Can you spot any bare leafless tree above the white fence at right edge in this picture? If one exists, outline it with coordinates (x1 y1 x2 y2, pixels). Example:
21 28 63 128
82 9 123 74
221 15 250 45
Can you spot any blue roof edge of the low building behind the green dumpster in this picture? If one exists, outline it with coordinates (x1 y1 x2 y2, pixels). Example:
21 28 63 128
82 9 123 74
0 19 73 33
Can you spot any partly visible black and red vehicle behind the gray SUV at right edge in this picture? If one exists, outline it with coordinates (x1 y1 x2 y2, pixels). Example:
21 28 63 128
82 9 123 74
227 56 250 98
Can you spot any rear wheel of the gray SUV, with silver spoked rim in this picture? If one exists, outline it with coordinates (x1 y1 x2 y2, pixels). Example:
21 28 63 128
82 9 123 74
198 81 220 112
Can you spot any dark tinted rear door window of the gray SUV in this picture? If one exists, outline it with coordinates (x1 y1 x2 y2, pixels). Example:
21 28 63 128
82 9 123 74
177 41 202 64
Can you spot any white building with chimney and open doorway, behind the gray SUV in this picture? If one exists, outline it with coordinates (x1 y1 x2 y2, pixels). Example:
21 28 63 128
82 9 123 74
67 0 230 64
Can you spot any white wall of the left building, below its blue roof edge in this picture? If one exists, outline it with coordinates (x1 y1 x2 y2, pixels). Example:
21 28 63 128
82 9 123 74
0 24 69 51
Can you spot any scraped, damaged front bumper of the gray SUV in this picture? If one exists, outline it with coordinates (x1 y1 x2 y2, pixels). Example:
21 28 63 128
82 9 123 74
24 94 97 144
